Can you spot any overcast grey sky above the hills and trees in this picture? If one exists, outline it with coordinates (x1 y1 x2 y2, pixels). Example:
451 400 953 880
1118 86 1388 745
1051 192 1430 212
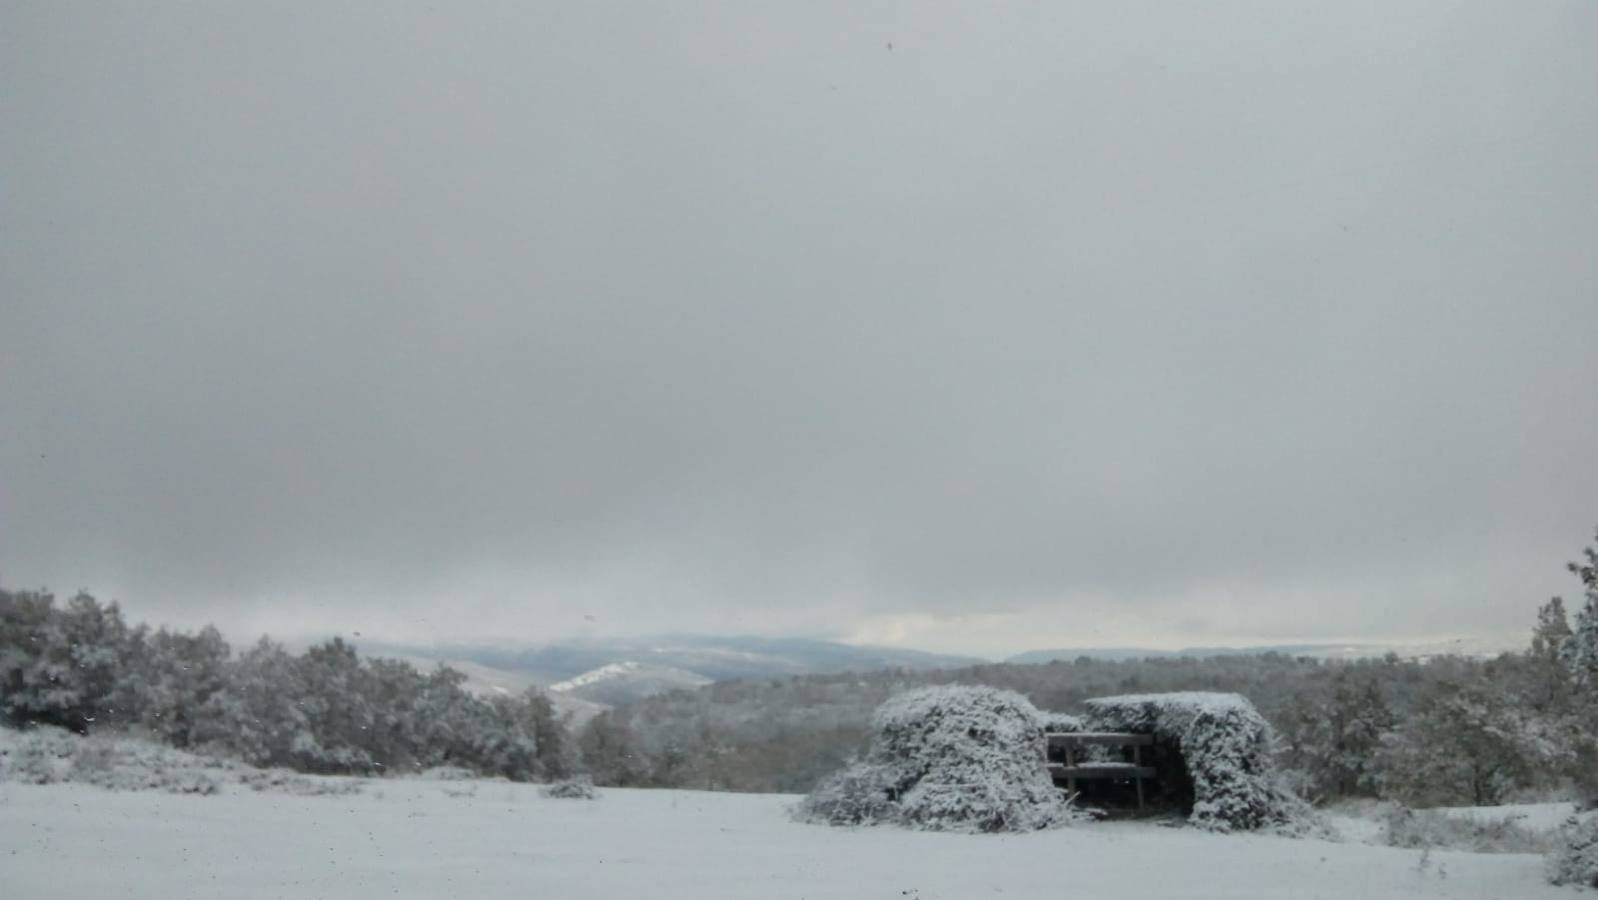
0 0 1598 654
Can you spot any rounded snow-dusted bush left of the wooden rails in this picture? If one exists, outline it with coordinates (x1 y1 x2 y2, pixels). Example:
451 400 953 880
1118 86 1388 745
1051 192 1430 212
797 686 1069 831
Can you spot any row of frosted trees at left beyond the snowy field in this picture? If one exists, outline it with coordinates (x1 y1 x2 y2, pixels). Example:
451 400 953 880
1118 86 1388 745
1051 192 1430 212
0 590 580 780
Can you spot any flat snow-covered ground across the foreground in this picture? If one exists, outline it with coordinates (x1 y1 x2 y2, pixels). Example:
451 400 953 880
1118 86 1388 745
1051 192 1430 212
0 779 1572 900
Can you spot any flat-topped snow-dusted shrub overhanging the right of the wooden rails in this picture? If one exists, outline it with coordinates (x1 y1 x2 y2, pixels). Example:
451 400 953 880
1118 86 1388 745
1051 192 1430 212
1083 692 1307 831
